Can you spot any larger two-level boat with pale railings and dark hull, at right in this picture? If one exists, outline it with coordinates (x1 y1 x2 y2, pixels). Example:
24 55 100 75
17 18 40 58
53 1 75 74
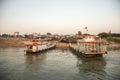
70 35 107 57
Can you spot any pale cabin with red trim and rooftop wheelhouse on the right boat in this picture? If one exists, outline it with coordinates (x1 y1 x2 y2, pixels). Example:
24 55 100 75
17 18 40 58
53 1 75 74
77 35 107 54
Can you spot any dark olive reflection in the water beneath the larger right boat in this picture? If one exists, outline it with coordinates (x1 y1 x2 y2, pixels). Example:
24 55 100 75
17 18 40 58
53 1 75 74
77 57 106 72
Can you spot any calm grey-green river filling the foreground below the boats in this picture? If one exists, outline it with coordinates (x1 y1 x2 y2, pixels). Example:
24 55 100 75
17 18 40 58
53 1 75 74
0 47 120 80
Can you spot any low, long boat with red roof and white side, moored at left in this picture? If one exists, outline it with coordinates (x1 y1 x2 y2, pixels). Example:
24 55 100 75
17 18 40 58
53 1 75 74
24 41 55 53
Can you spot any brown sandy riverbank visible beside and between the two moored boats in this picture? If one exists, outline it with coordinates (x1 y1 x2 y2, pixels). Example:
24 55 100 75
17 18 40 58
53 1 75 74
0 38 120 50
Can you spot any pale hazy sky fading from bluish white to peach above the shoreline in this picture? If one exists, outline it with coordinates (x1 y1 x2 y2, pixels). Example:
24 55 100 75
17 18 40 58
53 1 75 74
0 0 120 34
